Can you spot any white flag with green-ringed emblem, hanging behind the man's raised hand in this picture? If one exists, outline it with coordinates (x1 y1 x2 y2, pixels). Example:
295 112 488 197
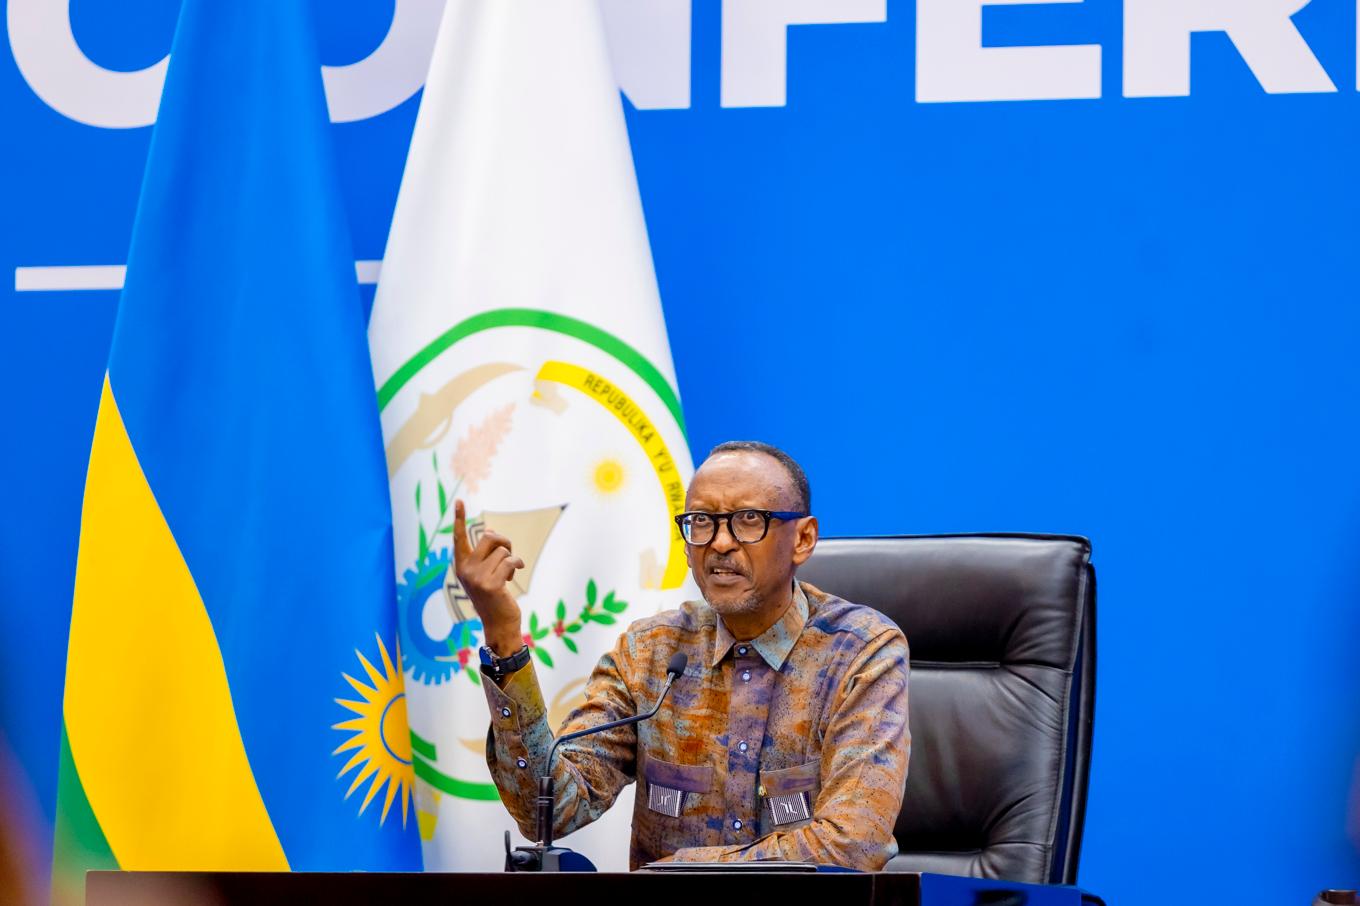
367 0 695 871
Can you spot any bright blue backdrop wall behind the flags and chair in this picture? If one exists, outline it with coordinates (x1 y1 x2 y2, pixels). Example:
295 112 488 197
0 0 1360 903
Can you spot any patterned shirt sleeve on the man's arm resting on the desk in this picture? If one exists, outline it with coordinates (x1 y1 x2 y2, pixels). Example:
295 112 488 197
670 628 911 871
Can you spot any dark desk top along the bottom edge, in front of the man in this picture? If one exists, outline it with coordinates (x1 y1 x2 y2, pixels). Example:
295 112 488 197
86 872 1099 906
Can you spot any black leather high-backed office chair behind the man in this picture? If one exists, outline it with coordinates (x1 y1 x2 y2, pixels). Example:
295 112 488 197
798 535 1096 884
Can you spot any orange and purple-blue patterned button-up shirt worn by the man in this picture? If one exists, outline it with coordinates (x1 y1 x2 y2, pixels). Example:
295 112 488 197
483 582 911 871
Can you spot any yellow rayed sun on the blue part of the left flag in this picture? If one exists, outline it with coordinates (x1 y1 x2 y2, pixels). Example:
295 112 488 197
332 634 415 827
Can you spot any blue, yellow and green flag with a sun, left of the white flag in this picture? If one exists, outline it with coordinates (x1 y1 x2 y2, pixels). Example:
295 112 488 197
54 0 420 899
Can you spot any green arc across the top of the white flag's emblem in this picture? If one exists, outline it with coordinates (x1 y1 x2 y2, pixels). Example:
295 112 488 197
378 309 685 435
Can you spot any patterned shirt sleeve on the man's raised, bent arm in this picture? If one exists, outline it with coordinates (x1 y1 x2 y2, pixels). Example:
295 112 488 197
481 637 638 839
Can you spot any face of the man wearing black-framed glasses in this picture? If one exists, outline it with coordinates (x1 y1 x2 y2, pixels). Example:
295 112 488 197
685 450 817 622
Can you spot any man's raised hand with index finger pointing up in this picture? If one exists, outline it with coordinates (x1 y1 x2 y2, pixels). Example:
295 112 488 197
453 501 524 657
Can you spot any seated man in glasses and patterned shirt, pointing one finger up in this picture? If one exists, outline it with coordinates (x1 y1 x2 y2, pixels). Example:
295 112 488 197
454 441 911 871
